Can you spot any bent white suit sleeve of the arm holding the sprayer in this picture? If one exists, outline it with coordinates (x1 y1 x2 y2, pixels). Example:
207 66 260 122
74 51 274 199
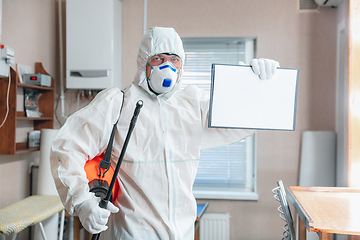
50 88 123 214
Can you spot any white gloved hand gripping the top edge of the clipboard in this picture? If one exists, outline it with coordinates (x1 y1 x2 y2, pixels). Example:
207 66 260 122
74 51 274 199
250 58 280 79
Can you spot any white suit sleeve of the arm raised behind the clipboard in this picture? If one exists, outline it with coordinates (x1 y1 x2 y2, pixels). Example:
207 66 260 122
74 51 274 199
200 87 255 150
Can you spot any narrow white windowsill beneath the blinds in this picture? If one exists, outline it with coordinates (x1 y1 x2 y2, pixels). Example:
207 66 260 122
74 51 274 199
193 190 259 201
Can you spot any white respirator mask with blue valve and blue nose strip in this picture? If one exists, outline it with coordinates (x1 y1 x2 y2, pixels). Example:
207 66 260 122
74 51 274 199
148 62 179 94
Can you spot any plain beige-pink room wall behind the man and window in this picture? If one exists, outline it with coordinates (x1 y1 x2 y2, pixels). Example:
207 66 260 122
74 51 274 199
0 0 339 240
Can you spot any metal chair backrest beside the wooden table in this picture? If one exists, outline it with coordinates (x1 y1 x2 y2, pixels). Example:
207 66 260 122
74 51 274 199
272 180 296 240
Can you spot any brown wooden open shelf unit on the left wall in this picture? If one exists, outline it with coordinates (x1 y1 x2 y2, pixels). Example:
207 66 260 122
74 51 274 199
0 63 55 154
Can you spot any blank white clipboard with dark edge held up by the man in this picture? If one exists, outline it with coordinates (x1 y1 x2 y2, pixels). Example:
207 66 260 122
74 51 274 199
208 64 299 131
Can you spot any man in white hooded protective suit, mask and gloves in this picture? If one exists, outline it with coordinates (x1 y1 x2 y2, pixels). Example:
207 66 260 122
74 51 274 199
51 27 279 240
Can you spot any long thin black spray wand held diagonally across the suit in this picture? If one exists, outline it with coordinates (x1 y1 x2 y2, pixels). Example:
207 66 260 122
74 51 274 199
91 100 143 240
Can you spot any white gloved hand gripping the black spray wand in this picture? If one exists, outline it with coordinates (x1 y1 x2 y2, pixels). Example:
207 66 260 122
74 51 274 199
75 196 119 234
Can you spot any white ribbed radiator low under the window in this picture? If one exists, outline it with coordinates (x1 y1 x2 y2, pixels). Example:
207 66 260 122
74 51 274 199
199 213 230 240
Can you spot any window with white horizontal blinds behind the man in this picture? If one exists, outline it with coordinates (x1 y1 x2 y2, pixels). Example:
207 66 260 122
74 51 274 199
182 38 258 200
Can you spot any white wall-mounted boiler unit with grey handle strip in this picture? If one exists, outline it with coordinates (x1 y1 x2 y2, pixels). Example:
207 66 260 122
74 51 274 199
66 0 121 89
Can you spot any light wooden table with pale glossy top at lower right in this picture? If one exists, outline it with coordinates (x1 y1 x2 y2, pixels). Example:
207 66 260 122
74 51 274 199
286 186 360 240
